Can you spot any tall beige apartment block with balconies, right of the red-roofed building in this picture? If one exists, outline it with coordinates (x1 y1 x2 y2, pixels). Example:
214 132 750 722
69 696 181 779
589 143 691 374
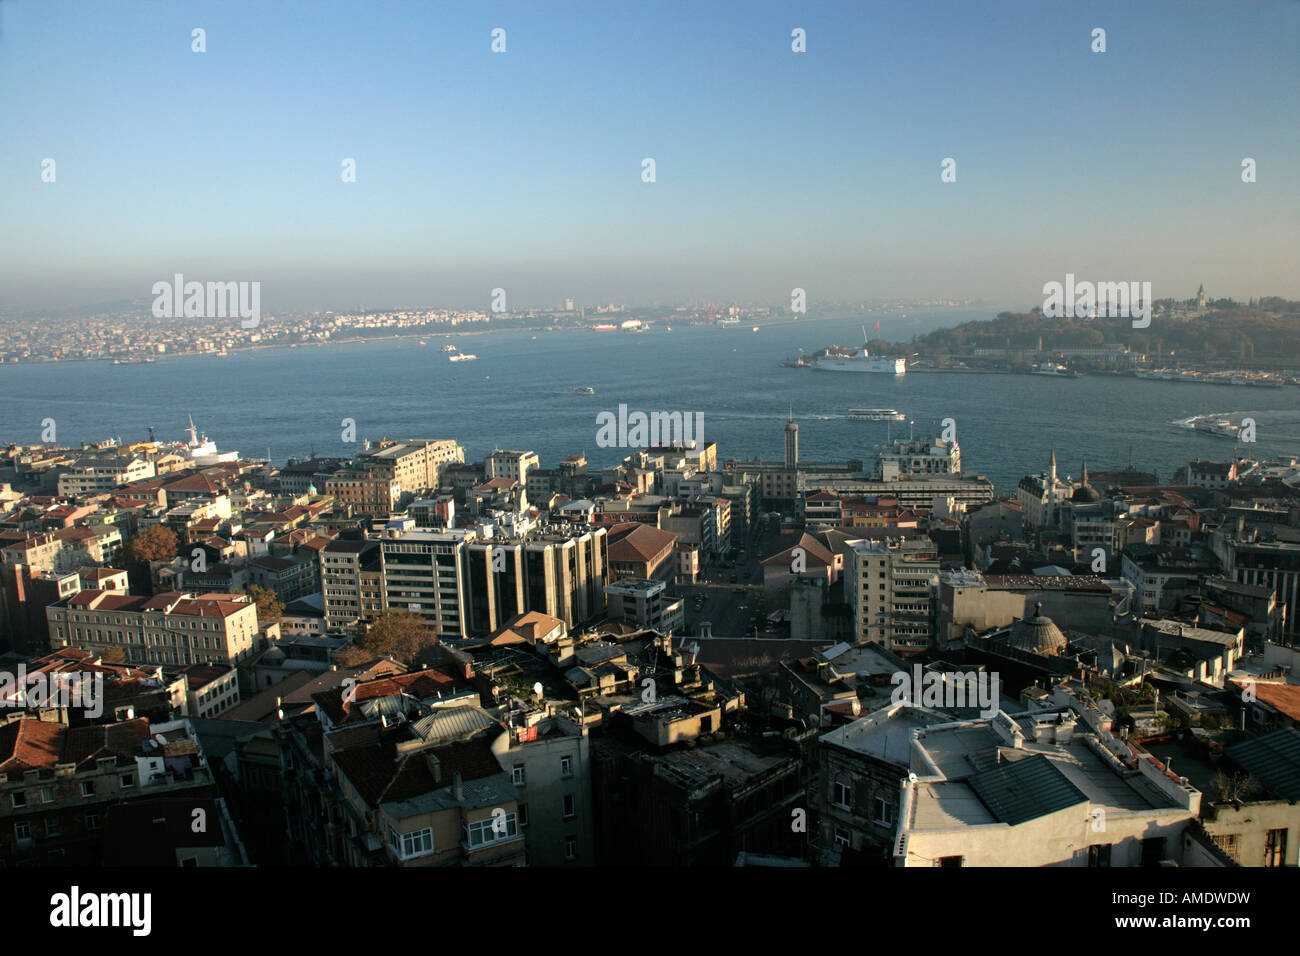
844 538 939 654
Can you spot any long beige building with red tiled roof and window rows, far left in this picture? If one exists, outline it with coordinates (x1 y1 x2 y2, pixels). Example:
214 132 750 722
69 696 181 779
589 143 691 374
46 591 257 665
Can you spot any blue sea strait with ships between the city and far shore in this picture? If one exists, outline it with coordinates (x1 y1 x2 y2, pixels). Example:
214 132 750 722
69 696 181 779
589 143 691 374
0 308 1300 494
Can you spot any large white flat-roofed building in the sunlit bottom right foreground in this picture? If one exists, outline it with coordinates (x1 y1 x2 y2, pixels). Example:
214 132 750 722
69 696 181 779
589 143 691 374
889 685 1201 868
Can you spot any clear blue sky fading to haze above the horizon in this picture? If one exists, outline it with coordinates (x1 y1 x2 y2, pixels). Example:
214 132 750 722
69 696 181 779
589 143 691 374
0 0 1300 311
